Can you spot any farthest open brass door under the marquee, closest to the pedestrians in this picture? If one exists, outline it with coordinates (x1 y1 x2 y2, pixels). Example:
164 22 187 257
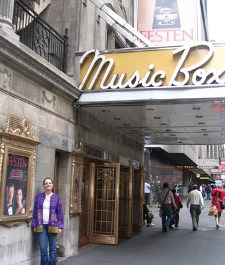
132 169 144 233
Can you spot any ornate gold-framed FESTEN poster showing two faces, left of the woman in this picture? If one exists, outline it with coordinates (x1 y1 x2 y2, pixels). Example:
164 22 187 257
0 113 39 226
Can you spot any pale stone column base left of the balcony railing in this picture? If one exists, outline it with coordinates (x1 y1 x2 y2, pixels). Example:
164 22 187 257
0 0 19 39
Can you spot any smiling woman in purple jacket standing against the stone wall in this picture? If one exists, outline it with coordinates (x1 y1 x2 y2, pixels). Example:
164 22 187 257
32 178 64 265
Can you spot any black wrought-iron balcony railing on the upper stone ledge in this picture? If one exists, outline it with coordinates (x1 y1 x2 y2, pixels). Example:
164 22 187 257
13 0 68 73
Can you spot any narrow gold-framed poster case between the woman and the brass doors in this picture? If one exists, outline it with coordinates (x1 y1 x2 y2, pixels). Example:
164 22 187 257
70 154 83 216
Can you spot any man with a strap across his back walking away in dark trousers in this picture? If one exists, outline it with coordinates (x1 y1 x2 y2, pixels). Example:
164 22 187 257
158 182 176 232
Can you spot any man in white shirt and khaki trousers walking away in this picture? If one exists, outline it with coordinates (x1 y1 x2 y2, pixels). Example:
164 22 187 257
186 184 204 231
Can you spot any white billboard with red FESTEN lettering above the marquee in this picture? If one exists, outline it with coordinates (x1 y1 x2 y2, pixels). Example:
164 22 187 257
138 0 198 46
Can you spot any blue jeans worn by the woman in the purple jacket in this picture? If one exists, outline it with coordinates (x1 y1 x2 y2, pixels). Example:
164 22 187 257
37 225 57 265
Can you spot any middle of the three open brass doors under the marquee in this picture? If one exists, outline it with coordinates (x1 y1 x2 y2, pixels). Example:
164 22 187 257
119 167 133 238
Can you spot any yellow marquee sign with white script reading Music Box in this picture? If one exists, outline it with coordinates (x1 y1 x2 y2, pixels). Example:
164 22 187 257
80 42 225 90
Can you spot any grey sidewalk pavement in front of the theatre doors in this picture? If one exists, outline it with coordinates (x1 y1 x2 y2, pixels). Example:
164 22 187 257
58 200 225 265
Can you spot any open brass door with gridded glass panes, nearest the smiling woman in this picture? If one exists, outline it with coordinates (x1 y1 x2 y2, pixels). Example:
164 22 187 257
89 163 120 244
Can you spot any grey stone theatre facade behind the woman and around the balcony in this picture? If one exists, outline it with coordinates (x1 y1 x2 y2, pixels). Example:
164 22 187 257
0 0 143 265
